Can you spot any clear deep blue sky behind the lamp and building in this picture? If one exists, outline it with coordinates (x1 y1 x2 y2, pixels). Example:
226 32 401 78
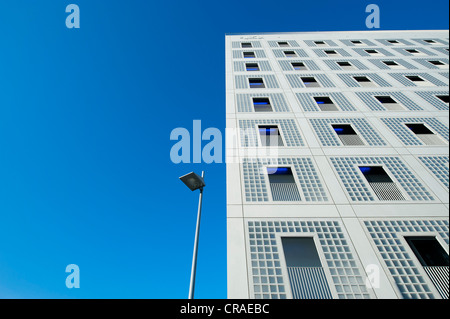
0 0 449 298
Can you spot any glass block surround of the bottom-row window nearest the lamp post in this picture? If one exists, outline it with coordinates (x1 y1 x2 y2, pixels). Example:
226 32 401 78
247 219 374 299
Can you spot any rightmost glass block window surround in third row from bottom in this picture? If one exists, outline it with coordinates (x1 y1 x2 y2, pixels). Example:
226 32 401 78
381 117 448 145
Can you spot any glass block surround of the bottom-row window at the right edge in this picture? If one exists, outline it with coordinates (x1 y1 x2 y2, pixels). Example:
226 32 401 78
364 219 449 299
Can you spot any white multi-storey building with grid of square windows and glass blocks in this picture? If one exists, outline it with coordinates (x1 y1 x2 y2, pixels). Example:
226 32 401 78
226 31 449 299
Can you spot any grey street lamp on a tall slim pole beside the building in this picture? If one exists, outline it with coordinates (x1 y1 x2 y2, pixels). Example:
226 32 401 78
180 171 205 299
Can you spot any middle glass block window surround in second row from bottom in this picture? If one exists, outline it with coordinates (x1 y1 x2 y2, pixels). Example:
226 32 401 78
330 156 434 202
